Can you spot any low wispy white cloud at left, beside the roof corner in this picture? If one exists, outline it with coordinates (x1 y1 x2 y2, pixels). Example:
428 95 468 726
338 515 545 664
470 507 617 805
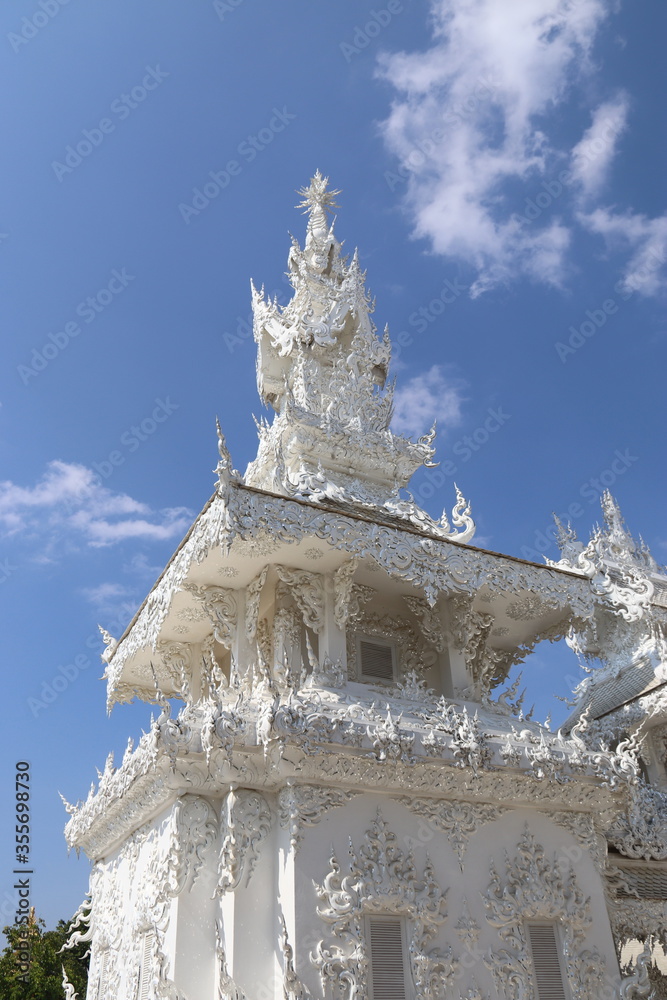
0 461 191 548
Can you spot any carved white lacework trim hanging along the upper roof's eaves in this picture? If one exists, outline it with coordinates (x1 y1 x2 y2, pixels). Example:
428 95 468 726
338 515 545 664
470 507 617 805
106 472 594 705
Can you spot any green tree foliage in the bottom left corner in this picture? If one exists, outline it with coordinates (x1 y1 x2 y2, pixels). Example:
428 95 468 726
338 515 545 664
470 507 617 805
0 913 89 1000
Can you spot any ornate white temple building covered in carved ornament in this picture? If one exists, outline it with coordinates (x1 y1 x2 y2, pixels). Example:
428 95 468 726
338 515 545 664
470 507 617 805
66 173 667 1000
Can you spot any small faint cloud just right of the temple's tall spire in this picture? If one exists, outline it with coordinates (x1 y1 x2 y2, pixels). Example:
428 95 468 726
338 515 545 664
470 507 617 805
392 365 464 436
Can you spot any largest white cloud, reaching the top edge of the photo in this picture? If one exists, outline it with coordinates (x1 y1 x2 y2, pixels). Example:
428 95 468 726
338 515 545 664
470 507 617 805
380 0 608 296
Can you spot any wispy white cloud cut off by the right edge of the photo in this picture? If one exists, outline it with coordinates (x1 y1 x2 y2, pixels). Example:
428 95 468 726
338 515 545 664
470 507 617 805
580 208 667 296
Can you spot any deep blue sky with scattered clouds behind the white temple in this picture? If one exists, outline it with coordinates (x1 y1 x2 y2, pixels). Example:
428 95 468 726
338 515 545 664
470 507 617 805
0 0 667 924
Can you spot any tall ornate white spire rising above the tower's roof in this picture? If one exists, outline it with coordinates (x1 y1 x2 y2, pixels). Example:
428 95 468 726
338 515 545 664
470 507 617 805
246 171 474 541
